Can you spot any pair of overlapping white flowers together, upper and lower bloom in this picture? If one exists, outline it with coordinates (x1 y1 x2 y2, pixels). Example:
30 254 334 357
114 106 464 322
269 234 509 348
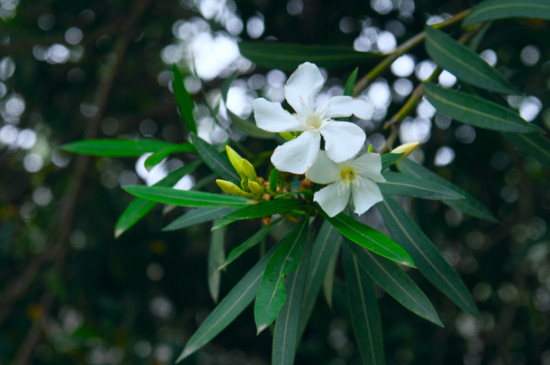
253 62 385 217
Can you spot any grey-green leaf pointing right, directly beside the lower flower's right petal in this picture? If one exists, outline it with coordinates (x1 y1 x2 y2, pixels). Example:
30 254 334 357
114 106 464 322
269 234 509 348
384 171 462 200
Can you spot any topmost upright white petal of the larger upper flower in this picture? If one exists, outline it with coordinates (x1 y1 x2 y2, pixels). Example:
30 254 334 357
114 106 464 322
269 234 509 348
285 62 325 114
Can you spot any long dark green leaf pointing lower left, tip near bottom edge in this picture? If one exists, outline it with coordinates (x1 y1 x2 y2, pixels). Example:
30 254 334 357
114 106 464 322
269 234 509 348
176 249 275 362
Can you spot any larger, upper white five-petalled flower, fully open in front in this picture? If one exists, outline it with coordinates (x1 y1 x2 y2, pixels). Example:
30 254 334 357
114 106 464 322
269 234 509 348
252 62 374 174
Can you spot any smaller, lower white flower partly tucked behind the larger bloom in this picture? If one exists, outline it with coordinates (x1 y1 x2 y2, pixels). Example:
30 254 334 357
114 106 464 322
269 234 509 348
306 151 386 217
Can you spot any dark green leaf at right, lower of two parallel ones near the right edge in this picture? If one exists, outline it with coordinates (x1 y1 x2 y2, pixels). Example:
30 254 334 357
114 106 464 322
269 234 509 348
424 83 540 133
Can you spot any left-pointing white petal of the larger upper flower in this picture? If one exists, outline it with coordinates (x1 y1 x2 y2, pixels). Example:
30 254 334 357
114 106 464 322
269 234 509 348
252 98 305 132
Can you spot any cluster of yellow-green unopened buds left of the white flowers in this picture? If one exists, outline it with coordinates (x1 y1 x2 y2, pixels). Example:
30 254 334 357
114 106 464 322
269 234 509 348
216 146 265 200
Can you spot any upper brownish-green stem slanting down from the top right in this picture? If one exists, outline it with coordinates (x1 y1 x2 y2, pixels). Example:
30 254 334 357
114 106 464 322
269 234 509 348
353 9 470 96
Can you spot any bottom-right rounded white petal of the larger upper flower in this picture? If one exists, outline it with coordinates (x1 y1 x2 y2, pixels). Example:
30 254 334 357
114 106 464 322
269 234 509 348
321 122 367 162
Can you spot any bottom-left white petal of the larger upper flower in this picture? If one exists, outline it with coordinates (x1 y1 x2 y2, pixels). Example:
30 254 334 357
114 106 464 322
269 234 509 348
271 131 321 175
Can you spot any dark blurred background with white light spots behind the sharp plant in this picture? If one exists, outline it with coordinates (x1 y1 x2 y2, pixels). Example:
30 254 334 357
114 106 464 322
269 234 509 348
0 0 550 365
